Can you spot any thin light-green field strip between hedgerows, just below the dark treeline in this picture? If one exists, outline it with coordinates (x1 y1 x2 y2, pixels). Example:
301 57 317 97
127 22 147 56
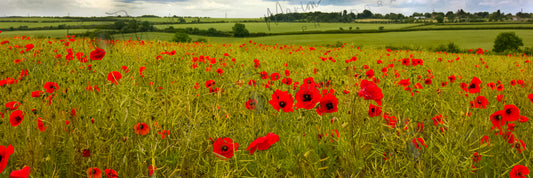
155 22 417 33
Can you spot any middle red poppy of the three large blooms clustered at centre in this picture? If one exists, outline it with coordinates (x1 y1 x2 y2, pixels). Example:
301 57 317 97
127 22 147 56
295 82 321 109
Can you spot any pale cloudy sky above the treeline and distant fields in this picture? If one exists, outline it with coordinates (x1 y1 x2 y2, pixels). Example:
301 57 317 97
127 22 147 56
0 0 533 18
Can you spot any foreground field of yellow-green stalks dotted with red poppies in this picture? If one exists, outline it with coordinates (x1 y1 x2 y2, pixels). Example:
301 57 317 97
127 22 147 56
0 32 533 177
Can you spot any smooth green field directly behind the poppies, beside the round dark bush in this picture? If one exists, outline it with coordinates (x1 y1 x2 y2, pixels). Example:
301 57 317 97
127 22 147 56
96 30 533 50
